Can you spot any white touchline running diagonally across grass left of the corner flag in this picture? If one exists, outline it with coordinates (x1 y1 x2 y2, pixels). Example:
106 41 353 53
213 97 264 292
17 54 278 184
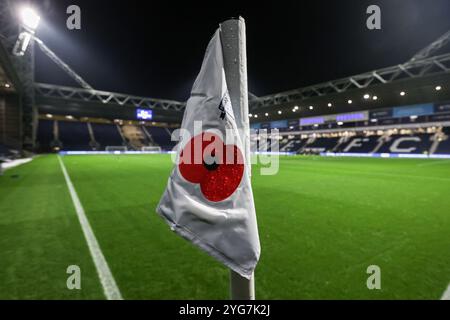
58 156 123 300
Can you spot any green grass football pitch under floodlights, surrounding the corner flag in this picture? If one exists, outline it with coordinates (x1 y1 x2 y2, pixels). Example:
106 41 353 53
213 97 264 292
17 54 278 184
0 155 450 299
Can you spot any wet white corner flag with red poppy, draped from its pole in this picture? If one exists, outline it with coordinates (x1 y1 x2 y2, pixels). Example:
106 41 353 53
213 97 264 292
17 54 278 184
156 20 260 279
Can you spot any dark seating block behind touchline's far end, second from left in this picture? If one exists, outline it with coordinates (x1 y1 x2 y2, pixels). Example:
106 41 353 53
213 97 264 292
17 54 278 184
58 121 91 151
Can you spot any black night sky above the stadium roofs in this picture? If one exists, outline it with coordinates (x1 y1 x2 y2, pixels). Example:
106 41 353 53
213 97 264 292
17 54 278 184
27 0 450 100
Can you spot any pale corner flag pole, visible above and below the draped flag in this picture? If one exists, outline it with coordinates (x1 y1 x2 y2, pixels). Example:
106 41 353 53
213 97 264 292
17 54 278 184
220 17 255 300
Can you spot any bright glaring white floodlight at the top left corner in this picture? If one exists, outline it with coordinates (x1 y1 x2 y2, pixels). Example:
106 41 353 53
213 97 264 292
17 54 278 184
13 7 41 56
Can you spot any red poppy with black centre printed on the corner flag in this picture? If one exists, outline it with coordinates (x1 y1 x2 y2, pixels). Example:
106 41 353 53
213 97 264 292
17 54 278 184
178 132 244 202
